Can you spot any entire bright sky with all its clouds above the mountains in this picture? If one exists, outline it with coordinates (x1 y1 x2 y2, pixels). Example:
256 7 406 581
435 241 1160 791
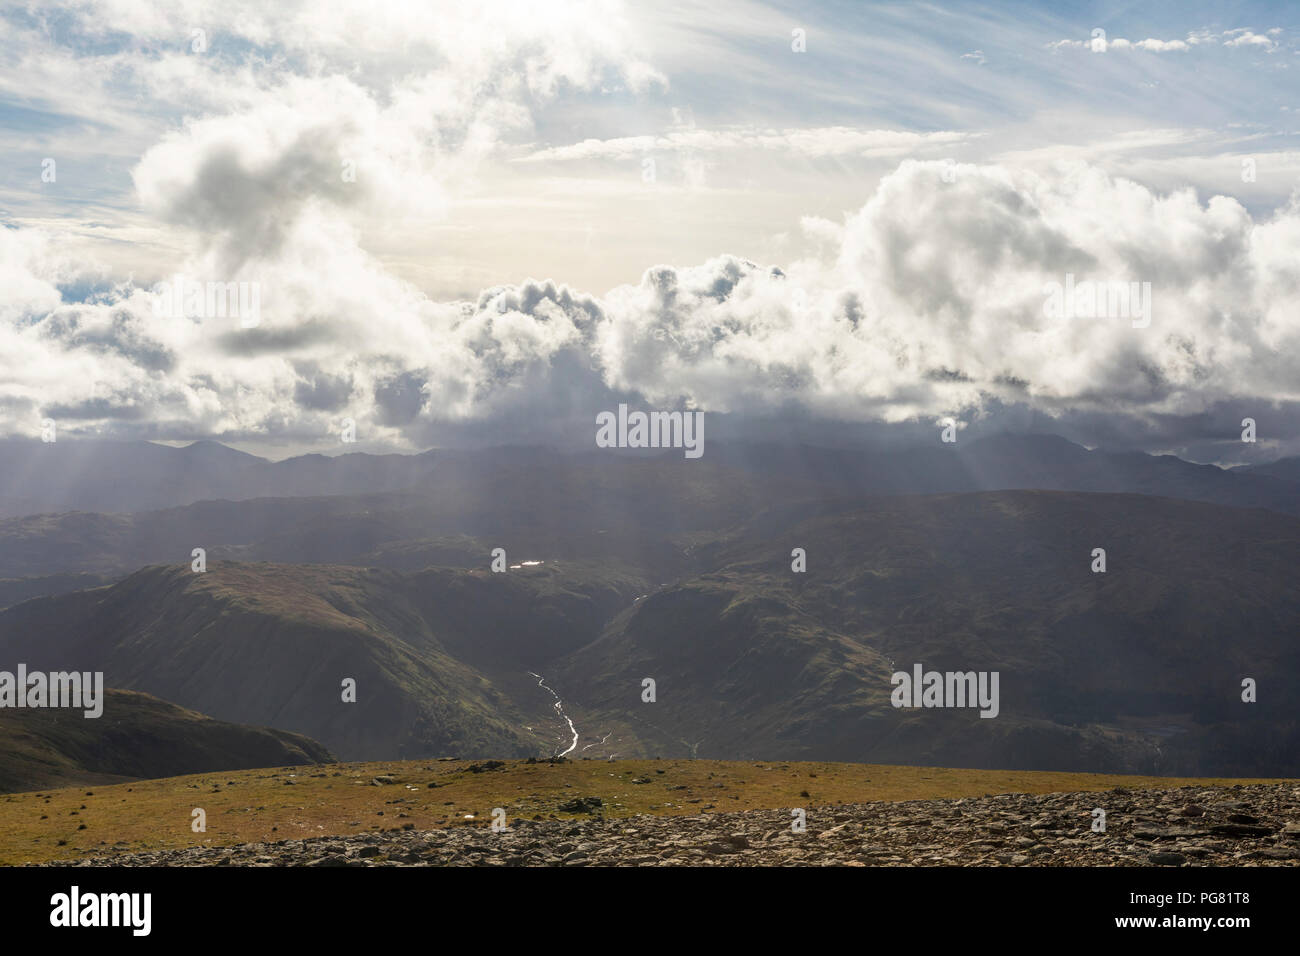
0 0 1300 463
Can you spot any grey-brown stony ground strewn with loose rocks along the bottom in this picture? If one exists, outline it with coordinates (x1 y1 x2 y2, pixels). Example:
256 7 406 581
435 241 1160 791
40 783 1300 866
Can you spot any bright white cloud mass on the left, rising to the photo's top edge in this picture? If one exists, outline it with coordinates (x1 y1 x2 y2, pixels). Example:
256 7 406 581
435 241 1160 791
0 1 662 442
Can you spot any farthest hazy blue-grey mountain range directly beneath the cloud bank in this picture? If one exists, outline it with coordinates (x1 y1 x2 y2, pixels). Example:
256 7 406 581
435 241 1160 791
0 433 1300 518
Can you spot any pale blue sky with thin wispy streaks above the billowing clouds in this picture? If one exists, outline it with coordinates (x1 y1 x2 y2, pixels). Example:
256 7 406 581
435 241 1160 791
0 3 1300 294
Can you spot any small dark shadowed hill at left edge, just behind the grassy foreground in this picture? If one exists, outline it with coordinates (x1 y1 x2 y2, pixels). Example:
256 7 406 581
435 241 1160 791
0 689 333 793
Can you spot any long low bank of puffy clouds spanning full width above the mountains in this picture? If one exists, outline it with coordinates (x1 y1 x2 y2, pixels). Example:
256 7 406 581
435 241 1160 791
0 160 1300 446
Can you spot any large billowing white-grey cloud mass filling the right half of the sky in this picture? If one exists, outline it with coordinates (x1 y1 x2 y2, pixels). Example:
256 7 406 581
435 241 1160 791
602 161 1300 429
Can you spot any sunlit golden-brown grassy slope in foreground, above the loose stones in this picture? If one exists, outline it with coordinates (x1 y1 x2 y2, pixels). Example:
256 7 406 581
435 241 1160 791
0 760 1289 865
